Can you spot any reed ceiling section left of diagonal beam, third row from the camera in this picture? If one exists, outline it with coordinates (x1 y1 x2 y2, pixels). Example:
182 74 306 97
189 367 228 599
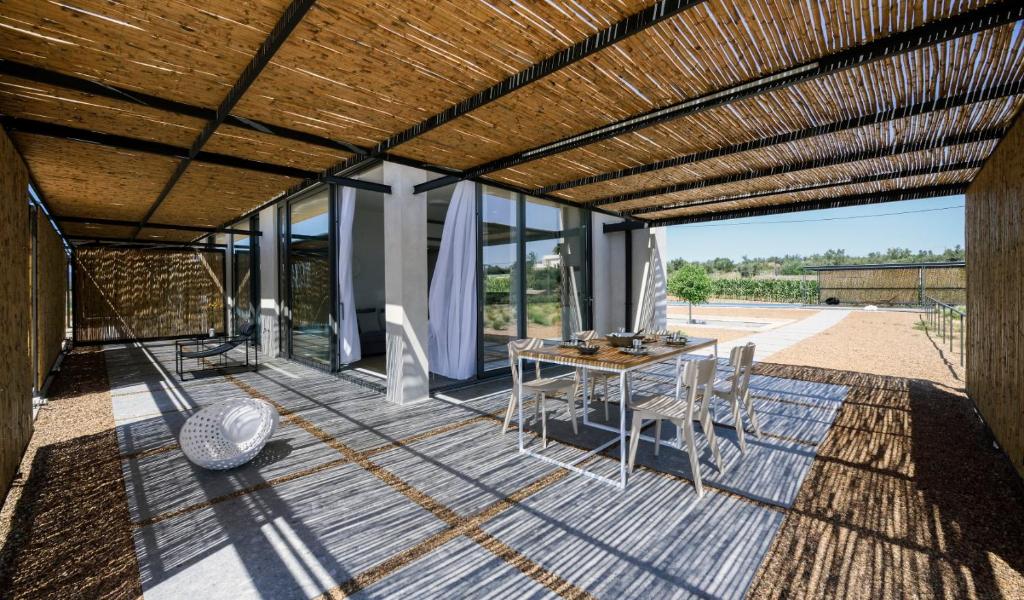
12 133 176 220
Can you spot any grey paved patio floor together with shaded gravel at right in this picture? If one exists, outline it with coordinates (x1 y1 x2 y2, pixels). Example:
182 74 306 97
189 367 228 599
0 344 1024 598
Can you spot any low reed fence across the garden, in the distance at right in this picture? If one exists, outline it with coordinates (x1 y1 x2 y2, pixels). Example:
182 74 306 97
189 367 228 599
818 266 967 305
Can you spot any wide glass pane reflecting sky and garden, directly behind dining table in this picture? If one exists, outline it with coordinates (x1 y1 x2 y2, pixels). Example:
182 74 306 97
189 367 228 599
523 193 587 340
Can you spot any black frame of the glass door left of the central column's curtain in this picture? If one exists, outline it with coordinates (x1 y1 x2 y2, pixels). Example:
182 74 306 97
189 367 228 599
279 183 341 372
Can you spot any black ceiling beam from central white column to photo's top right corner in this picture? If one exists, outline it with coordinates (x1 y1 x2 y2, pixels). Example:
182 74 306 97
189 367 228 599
416 0 1024 194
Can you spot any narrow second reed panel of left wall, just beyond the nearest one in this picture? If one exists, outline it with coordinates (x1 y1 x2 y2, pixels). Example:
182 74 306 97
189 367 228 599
36 211 68 389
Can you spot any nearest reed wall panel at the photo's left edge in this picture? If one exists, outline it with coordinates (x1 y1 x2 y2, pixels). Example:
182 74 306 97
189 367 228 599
0 131 32 502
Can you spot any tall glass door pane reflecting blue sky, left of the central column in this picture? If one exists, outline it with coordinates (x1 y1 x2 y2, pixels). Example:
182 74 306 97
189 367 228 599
288 189 331 366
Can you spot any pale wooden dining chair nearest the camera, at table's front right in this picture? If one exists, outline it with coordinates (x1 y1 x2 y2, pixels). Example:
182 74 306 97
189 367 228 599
629 356 725 497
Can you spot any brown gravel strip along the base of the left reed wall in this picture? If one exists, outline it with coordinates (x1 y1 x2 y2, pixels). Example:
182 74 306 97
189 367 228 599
0 348 141 598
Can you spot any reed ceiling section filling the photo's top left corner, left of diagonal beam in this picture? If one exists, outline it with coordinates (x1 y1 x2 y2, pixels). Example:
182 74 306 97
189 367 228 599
0 0 288 108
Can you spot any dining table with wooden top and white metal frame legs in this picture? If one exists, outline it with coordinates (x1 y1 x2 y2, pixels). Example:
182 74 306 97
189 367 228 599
516 337 718 489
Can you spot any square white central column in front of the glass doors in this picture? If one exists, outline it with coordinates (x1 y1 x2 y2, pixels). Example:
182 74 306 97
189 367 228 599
384 163 429 404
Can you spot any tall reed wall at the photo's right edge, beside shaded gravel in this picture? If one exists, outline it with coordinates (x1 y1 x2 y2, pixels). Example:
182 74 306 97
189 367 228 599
967 111 1024 477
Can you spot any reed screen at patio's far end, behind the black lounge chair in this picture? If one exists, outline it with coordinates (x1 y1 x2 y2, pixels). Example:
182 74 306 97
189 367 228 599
75 247 224 342
